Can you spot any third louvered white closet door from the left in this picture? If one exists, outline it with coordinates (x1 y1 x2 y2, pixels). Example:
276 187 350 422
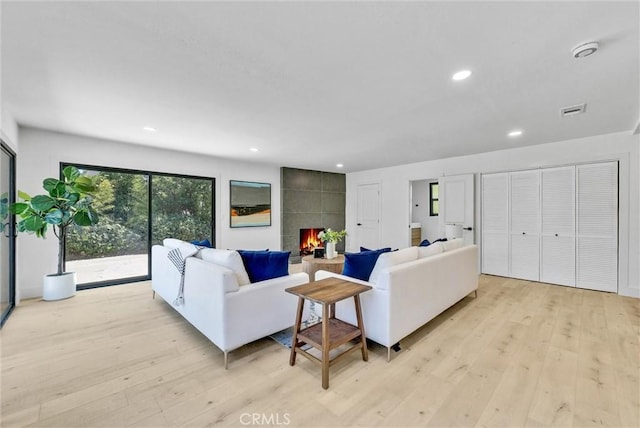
540 166 576 287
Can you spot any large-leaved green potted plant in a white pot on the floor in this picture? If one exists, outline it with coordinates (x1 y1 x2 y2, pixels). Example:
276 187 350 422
10 166 98 300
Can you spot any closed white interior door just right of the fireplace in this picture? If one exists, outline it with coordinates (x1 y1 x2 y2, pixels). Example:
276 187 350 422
356 183 380 249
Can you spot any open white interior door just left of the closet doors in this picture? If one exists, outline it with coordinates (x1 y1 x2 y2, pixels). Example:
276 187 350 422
438 174 475 245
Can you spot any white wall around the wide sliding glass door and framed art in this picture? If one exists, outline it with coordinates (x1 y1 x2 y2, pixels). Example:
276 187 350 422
16 128 281 298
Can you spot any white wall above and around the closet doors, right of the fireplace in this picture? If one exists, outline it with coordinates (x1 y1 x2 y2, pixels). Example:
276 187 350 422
346 132 640 297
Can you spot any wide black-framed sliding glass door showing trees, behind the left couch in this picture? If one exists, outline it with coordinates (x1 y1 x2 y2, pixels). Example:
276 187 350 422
62 165 215 289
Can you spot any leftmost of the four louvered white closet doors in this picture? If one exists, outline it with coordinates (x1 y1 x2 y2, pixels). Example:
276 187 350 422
482 173 509 276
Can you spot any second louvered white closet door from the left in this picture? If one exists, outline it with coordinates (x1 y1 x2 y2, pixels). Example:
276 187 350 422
509 170 540 281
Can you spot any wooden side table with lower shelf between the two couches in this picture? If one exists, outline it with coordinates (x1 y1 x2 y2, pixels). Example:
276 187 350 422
285 278 371 389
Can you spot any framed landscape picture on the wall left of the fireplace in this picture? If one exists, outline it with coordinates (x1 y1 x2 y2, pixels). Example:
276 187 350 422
229 180 271 227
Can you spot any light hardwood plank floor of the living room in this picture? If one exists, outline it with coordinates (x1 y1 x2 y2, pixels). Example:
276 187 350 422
0 276 640 427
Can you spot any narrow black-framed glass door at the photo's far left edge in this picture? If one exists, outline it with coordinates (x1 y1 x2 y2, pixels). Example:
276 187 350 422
0 140 15 326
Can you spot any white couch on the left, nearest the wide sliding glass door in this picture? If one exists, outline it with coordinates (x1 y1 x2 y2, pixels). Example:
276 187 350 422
151 239 309 368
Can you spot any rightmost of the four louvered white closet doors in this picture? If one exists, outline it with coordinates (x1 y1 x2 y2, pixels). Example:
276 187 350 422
576 162 618 292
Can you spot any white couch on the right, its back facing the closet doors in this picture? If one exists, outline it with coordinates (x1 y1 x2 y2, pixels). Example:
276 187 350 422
316 240 478 360
